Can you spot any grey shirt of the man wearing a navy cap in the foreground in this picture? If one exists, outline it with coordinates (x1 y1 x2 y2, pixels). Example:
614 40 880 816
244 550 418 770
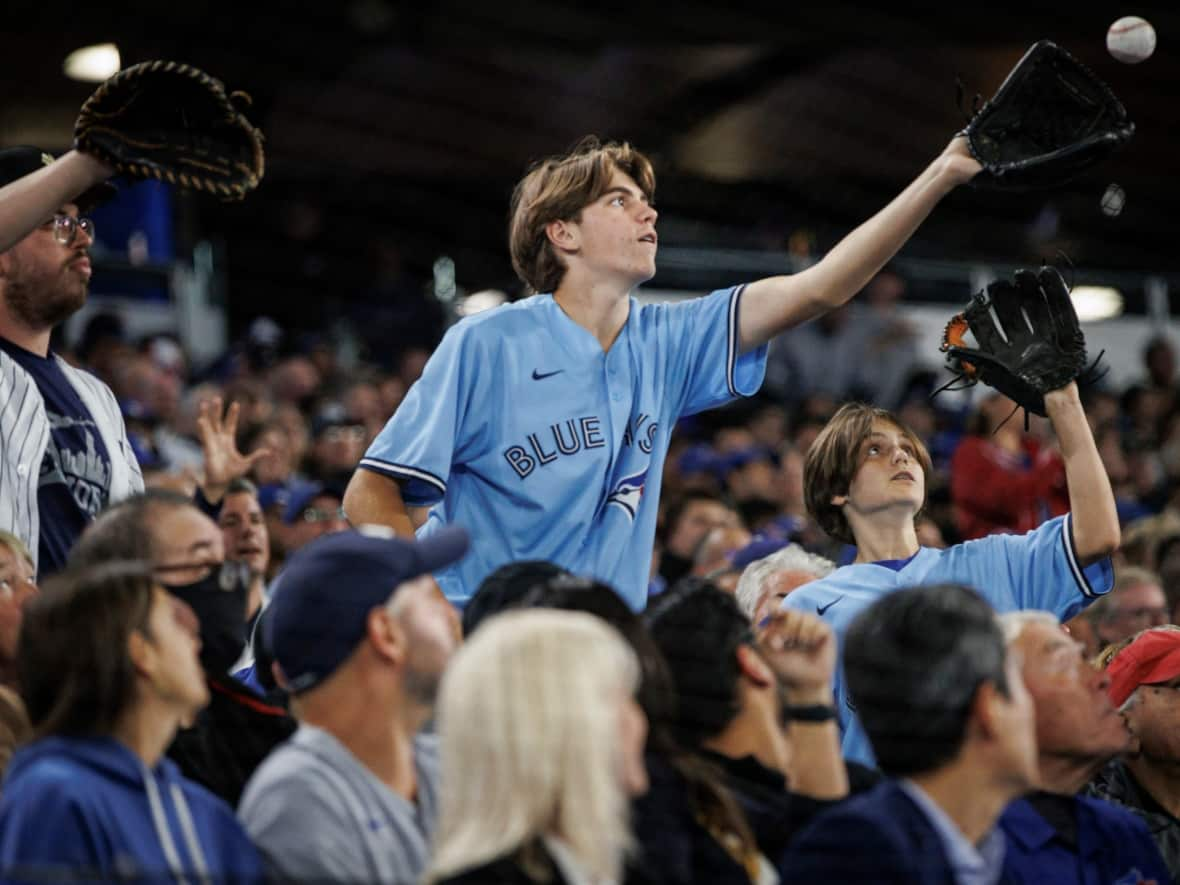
237 725 439 885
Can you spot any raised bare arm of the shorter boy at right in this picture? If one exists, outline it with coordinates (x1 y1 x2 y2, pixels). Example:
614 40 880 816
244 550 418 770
1044 381 1121 565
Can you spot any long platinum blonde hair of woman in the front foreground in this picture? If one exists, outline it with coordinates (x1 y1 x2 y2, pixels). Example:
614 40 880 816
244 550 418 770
425 609 640 883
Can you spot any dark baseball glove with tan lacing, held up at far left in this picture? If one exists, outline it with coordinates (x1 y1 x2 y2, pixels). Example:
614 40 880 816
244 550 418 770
74 61 263 199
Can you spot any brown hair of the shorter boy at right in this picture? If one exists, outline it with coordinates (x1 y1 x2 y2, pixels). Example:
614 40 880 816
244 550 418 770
804 402 933 544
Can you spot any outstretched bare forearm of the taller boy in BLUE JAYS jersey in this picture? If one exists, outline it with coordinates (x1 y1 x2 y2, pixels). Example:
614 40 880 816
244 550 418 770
739 137 981 350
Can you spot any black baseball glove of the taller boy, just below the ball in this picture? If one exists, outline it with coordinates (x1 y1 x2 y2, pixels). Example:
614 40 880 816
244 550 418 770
963 40 1135 190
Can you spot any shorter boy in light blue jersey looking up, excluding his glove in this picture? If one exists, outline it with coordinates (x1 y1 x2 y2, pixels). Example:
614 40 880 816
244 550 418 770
782 394 1120 765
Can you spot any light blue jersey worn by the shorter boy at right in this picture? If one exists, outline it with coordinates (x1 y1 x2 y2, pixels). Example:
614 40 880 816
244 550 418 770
782 513 1114 765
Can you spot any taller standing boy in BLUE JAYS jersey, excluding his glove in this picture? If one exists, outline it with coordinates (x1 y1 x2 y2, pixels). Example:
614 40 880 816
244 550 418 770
345 138 979 609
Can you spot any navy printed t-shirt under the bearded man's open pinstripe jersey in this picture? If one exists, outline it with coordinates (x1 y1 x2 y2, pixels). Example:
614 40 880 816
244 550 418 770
0 337 111 577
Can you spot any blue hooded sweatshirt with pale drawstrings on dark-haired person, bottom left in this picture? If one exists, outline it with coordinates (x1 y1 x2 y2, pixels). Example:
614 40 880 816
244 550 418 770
0 738 263 885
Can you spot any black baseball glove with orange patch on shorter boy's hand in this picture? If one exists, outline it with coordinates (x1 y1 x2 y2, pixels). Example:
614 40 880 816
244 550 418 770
942 267 1086 417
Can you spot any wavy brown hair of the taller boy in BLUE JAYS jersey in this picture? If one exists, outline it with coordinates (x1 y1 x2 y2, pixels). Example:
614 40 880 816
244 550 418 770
509 136 656 293
